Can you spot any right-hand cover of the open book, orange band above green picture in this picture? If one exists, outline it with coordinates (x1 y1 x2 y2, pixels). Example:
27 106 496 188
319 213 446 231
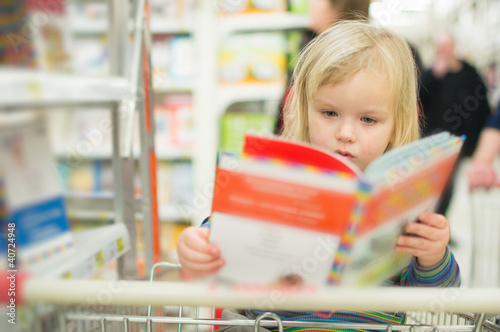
342 144 461 286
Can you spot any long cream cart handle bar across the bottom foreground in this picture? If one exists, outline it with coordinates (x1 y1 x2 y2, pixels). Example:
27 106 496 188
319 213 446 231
17 278 500 314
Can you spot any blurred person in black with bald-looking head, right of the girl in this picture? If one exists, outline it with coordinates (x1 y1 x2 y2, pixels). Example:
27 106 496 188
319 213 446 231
419 33 491 214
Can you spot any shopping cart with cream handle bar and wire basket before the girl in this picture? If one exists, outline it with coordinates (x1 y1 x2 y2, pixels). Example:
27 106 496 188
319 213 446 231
13 263 500 332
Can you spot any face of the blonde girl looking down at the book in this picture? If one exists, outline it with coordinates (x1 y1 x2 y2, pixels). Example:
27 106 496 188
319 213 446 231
308 70 394 171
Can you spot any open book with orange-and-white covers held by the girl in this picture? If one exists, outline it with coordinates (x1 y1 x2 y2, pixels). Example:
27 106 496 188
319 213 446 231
210 132 464 286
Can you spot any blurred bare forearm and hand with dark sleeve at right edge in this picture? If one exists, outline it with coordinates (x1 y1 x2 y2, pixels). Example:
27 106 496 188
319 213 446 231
467 103 500 190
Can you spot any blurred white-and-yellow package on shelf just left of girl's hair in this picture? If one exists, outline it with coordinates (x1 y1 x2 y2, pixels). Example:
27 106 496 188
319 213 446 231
220 32 286 84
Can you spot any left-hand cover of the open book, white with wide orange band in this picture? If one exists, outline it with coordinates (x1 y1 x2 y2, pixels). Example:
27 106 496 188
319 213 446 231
210 155 357 284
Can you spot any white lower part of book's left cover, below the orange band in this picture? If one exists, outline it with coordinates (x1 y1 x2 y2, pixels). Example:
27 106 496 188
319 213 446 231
210 213 340 285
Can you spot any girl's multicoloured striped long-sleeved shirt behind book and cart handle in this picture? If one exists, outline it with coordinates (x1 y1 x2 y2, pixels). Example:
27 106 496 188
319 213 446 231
201 218 461 331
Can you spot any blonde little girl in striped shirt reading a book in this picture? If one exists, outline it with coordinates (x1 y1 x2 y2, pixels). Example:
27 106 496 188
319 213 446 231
177 21 460 330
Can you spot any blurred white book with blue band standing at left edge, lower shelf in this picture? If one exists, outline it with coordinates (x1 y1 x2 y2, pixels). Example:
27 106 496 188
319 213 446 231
0 112 74 271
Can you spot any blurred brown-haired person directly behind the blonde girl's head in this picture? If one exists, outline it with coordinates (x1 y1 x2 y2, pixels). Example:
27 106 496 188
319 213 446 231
274 0 370 134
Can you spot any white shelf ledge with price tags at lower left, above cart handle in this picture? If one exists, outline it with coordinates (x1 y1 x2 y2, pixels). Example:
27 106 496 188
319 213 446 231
29 223 130 279
